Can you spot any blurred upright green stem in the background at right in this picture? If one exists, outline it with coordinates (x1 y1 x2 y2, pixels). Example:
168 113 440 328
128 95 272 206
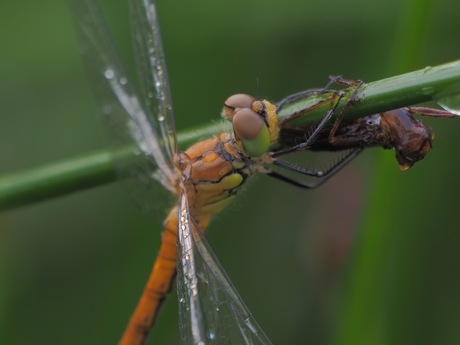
336 0 432 345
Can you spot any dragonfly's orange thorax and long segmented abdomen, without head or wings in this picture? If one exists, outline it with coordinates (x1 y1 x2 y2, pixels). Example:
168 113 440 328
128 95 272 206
119 134 247 345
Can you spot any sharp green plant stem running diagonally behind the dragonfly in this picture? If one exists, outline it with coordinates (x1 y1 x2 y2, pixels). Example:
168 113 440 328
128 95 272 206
0 60 460 210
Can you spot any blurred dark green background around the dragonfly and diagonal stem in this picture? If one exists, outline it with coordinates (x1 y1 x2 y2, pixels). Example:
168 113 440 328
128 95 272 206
0 0 460 344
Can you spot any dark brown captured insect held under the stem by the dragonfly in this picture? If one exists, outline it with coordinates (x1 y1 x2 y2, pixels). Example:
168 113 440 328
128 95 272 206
274 81 457 170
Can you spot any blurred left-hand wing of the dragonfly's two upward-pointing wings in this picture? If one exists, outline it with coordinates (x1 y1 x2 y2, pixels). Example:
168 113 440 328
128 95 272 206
70 0 176 212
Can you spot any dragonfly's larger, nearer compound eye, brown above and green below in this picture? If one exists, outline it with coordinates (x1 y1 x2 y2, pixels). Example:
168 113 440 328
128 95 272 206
233 108 270 157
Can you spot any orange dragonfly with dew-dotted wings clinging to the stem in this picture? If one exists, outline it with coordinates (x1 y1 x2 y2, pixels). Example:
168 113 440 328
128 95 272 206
71 0 456 345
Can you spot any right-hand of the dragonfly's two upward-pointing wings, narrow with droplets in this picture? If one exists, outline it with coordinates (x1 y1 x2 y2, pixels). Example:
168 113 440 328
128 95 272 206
130 0 177 161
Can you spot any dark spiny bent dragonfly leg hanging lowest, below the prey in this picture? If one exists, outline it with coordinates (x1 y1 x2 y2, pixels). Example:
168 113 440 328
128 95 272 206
267 146 363 189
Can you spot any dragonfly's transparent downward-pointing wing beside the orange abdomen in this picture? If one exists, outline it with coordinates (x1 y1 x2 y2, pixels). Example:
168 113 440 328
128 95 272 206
177 189 271 345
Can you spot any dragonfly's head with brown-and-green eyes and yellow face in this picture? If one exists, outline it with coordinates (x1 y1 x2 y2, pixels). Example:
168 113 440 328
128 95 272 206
222 94 279 157
